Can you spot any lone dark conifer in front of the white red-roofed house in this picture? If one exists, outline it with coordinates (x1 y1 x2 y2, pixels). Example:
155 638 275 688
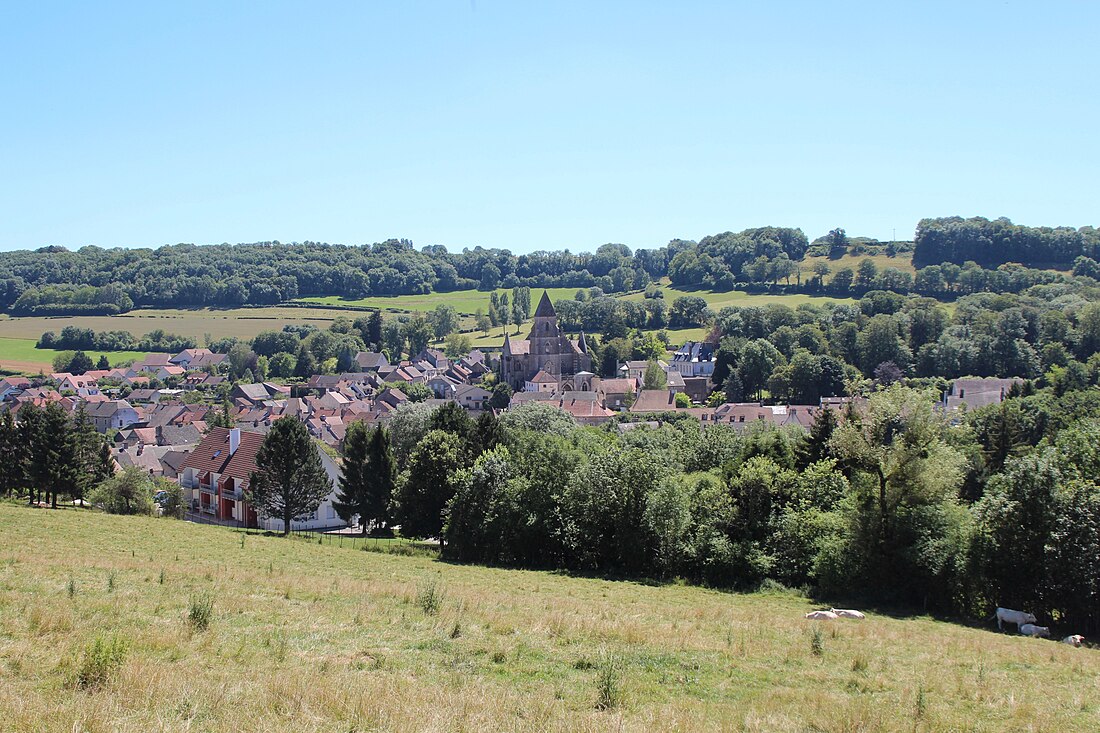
248 417 332 530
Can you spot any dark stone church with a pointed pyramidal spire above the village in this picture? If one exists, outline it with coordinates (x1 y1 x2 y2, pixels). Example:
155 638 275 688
501 291 592 393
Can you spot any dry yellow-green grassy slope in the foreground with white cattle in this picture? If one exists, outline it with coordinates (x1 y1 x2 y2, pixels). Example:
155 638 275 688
0 504 1100 733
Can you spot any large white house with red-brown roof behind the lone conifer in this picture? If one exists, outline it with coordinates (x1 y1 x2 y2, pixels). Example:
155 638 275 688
179 427 347 532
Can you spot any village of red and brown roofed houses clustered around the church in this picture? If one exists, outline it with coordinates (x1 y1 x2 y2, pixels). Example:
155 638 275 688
0 293 1016 530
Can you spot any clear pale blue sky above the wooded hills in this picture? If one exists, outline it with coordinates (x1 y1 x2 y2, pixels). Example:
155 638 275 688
0 0 1100 252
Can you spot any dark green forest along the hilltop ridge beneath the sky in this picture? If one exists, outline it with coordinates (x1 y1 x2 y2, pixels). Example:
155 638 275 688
0 217 1100 316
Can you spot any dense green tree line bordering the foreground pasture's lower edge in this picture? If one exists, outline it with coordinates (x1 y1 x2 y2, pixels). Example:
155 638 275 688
327 374 1100 631
